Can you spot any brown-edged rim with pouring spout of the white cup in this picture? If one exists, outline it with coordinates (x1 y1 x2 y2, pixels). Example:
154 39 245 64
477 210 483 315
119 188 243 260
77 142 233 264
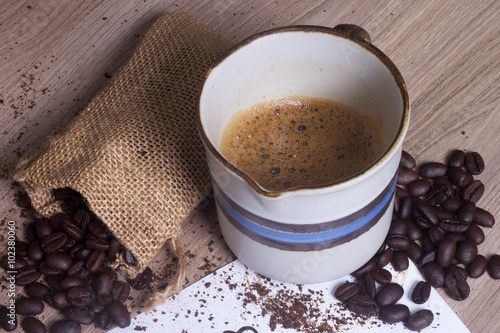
196 25 410 197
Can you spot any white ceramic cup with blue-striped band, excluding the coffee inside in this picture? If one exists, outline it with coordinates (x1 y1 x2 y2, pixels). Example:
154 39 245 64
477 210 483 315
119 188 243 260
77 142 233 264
197 25 409 283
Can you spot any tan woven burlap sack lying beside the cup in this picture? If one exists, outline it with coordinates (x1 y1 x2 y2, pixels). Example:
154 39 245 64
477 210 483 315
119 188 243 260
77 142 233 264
14 12 231 302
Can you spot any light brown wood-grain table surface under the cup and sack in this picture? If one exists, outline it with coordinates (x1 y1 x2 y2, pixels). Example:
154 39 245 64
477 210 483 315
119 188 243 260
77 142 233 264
0 0 500 332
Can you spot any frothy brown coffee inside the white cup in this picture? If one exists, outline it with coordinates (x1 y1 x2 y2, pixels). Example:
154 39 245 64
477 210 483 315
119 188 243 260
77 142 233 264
220 97 385 191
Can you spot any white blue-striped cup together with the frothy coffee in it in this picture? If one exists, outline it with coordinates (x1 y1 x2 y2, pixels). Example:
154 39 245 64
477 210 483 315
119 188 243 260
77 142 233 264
197 25 410 283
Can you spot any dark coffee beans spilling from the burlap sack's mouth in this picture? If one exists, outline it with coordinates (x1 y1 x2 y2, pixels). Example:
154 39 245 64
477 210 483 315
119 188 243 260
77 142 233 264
0 189 152 333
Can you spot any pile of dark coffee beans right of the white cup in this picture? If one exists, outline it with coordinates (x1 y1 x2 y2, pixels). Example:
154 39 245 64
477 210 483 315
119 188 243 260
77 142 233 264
335 150 500 331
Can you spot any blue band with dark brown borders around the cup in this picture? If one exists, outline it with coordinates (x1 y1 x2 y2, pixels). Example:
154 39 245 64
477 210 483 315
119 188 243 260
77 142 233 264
213 175 396 251
